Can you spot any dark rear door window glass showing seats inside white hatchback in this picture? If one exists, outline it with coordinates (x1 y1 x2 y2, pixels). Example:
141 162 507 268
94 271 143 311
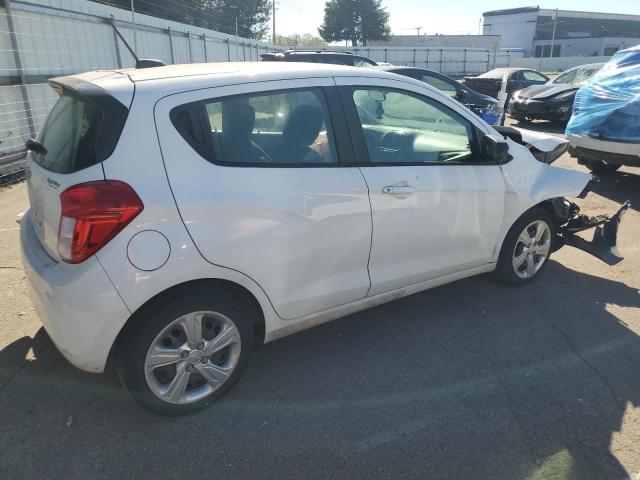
178 89 337 166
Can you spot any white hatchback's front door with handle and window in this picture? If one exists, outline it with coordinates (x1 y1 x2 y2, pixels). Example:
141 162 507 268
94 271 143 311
336 78 505 295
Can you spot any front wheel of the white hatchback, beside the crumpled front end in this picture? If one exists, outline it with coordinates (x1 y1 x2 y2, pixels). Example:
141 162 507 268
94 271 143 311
495 207 556 286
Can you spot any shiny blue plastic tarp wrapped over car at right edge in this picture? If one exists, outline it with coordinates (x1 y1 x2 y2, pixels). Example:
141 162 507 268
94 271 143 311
566 45 640 143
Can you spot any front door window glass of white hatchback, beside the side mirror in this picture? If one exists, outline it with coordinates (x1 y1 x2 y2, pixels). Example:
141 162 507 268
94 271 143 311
353 88 474 164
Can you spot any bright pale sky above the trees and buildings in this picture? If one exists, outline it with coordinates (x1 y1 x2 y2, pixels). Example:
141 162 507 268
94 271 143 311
276 0 640 35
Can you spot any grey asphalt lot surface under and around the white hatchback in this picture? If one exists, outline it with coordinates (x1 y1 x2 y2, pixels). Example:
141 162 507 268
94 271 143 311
0 124 640 480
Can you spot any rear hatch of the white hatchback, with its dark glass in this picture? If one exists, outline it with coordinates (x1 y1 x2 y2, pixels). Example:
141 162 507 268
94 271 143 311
25 72 130 261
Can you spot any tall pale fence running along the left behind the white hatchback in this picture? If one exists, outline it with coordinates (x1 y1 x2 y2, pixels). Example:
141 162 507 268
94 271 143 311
0 0 273 185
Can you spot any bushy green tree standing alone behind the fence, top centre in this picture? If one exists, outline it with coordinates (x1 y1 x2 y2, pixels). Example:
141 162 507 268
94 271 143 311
318 0 391 46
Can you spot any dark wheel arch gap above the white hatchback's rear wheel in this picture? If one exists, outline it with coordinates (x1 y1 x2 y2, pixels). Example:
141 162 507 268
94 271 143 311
106 278 266 367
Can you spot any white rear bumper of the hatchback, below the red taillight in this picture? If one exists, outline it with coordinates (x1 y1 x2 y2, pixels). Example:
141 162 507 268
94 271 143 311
20 212 130 372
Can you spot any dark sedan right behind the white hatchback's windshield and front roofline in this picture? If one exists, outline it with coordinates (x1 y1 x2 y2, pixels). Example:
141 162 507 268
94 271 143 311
375 66 499 123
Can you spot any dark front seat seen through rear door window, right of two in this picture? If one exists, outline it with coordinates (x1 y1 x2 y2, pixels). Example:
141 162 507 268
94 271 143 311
274 105 324 163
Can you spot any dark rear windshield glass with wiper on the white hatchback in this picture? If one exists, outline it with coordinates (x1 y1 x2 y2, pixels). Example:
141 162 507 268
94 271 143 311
32 91 103 173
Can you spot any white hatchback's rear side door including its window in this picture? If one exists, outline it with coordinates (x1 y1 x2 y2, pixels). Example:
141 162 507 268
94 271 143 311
155 79 371 319
